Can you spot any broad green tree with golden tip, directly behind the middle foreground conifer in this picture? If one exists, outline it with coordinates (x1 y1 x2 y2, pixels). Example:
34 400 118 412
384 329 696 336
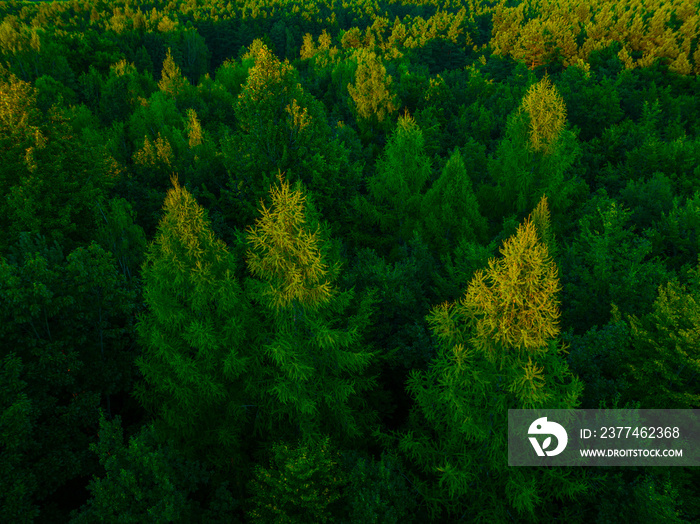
221 40 359 231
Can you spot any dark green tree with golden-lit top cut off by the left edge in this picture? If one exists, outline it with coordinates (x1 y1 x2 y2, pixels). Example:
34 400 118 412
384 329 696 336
0 69 107 249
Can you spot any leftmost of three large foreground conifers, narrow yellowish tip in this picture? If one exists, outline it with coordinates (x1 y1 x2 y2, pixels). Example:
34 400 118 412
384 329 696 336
136 179 255 470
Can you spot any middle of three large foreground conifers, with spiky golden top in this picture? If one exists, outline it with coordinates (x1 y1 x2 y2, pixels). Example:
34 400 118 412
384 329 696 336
246 174 374 439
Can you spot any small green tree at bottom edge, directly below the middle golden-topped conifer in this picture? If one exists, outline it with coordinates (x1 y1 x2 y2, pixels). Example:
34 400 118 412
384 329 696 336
248 437 347 524
